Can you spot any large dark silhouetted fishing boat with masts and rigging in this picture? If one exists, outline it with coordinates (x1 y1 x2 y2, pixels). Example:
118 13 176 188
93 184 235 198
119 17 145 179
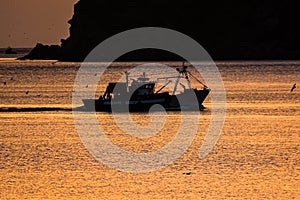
82 65 210 112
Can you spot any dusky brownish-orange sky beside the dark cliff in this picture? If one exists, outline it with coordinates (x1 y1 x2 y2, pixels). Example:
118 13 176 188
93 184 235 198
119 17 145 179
0 0 78 48
